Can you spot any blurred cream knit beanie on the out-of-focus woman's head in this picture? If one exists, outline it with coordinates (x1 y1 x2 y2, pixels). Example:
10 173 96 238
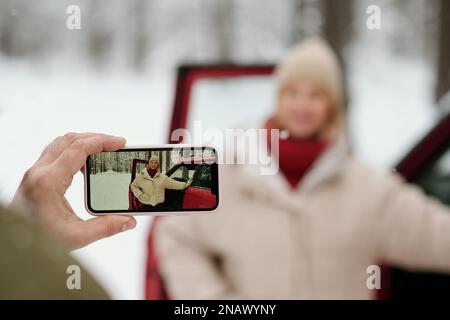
275 38 344 112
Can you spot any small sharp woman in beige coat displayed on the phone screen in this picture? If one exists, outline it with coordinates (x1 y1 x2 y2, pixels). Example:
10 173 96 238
131 156 192 211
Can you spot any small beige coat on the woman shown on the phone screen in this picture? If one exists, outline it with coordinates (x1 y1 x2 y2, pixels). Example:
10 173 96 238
131 169 186 206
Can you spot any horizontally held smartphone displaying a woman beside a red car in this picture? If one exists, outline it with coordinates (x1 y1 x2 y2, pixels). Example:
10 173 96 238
85 145 219 215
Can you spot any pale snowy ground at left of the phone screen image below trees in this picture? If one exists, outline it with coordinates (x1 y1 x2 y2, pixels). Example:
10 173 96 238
90 170 131 210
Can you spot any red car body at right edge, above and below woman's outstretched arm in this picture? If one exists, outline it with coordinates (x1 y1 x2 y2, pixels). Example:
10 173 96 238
384 110 450 299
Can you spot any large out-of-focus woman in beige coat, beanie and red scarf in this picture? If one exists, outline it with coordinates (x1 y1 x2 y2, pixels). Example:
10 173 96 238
155 39 450 299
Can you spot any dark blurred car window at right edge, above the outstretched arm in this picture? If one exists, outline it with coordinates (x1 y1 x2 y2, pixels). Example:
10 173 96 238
417 147 450 205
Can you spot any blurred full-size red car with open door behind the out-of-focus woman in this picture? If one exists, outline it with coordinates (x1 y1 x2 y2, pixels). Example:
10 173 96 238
146 65 450 299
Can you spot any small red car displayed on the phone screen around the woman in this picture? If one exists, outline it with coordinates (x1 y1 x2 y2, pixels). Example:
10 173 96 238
128 157 217 211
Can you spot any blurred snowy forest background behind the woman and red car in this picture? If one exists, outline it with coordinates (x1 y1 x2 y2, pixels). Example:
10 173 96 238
0 0 450 299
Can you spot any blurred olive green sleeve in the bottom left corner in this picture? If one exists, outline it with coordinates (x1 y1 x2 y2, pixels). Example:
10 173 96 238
0 207 109 299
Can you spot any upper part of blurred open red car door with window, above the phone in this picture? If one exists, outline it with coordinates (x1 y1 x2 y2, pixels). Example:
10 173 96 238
168 65 275 143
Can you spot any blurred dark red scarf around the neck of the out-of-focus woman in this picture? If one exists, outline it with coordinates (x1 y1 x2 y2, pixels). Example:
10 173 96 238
266 119 327 189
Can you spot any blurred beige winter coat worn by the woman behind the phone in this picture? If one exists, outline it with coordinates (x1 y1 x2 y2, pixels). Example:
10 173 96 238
155 136 450 299
